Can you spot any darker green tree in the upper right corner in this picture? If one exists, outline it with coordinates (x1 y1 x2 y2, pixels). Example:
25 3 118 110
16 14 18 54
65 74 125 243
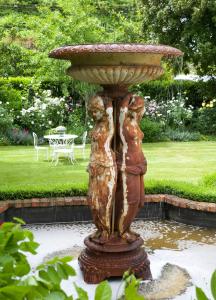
142 0 216 75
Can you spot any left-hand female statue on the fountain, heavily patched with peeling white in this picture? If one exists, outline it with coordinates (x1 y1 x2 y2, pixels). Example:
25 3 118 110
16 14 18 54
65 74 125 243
88 95 116 244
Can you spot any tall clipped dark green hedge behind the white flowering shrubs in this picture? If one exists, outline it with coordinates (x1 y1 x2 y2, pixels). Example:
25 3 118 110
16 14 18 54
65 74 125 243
0 77 216 107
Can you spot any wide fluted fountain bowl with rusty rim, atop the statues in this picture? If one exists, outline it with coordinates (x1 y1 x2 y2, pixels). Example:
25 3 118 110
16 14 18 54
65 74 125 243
49 44 183 86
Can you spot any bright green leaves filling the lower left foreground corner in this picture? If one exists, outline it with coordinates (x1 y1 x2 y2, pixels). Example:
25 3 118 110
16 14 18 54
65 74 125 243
0 218 80 300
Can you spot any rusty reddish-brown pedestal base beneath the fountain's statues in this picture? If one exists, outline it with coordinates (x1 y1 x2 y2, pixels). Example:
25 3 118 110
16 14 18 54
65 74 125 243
79 237 152 284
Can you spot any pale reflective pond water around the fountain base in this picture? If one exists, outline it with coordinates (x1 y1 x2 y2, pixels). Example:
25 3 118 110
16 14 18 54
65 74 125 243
28 220 216 300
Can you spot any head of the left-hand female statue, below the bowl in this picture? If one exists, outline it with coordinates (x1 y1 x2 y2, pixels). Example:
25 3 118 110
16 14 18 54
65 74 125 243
88 96 106 121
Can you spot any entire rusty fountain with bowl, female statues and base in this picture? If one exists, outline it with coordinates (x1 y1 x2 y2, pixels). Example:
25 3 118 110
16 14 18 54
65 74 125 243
49 44 183 283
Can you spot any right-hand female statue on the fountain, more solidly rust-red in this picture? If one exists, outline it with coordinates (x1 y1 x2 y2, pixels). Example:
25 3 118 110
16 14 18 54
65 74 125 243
115 94 147 242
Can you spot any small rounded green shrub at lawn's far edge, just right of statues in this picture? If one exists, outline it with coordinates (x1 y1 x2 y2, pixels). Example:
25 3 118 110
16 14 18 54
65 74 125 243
140 117 164 143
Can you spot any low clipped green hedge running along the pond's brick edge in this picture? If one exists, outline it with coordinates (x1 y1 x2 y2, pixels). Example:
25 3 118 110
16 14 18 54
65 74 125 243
0 180 216 203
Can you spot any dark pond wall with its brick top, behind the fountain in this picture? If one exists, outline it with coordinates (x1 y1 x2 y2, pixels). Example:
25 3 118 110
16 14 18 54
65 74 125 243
0 194 216 228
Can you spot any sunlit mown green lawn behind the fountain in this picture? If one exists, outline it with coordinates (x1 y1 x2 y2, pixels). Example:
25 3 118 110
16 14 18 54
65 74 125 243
0 142 216 201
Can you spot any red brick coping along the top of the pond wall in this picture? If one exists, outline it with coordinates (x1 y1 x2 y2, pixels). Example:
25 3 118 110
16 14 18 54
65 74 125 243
0 195 216 213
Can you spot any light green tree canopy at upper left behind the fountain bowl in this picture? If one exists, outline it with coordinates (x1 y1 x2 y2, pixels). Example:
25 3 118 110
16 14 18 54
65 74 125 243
0 0 143 80
